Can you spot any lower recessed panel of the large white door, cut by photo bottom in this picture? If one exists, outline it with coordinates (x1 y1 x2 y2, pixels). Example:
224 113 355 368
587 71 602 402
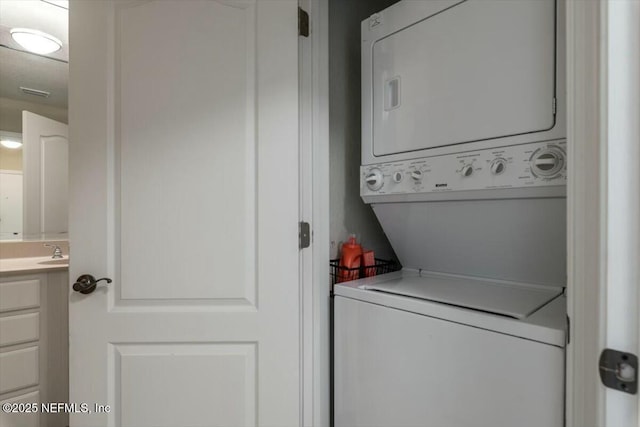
109 342 258 427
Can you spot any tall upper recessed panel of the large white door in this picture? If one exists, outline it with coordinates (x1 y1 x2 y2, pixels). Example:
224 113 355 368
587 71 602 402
113 1 258 310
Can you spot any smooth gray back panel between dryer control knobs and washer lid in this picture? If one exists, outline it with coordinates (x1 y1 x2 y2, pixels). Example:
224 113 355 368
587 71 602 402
374 200 567 286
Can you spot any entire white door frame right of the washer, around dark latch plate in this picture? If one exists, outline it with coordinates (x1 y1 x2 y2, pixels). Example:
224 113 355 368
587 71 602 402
566 0 640 427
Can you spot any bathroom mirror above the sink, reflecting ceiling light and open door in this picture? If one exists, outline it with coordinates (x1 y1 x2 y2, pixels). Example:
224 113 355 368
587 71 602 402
0 0 69 240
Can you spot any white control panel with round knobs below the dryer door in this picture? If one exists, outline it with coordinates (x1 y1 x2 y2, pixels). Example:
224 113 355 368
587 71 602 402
360 140 567 196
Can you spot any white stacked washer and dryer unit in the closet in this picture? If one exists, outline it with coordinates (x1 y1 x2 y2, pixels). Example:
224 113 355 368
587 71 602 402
334 0 568 427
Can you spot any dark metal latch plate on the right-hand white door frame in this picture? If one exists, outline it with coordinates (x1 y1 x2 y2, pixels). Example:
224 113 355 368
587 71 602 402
598 348 638 394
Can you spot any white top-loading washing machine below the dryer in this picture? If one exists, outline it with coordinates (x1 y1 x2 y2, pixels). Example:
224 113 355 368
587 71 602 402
334 269 566 427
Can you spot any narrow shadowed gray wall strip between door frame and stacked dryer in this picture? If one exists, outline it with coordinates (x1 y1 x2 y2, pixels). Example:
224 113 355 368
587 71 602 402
329 0 398 259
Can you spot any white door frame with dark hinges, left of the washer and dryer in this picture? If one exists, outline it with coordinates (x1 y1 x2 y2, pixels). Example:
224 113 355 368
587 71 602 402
298 0 331 426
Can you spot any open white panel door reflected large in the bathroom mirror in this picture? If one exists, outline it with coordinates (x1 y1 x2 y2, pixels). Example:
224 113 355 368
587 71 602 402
22 111 69 238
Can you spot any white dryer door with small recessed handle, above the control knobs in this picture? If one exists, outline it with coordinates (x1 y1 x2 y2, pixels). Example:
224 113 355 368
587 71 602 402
371 0 556 156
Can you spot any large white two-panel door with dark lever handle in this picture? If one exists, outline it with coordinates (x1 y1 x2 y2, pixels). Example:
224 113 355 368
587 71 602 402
69 0 300 427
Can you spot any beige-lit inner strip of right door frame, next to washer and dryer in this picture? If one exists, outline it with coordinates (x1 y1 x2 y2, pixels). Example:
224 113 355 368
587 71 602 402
565 1 606 427
